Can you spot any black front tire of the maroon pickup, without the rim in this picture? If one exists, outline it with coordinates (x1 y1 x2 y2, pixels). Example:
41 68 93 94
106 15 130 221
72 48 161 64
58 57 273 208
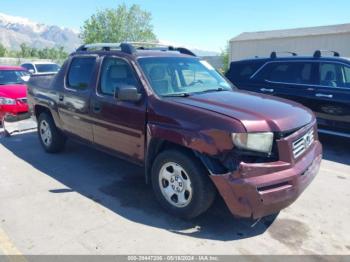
152 150 216 219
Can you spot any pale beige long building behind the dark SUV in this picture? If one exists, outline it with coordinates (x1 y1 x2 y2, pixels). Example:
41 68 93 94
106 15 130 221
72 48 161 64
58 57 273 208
229 24 350 61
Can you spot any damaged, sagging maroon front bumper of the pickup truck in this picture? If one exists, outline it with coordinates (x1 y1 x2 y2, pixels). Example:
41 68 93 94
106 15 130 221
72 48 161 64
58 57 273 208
211 127 322 219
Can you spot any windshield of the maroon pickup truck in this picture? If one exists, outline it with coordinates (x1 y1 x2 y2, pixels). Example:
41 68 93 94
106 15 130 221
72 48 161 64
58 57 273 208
138 57 232 97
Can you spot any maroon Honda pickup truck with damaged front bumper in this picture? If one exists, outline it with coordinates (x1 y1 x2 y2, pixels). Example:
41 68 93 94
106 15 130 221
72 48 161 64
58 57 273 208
28 43 322 218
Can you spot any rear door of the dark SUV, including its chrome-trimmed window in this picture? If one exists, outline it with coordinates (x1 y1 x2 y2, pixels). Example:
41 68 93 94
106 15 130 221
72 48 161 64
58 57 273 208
249 61 317 109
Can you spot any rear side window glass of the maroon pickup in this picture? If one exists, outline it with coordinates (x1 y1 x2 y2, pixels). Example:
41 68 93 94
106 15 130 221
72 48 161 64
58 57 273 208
67 57 96 90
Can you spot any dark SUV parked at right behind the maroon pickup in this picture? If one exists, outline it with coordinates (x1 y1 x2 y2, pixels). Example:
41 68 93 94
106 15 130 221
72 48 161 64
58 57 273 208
226 51 350 137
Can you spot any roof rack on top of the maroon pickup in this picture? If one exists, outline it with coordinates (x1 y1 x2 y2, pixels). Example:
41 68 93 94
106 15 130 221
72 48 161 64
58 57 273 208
76 42 196 56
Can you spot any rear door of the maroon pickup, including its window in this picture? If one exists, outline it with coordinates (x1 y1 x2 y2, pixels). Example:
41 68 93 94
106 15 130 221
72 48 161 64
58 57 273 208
58 56 96 142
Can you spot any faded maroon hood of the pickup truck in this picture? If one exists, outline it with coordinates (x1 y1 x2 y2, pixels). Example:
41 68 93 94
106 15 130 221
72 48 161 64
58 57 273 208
174 91 314 132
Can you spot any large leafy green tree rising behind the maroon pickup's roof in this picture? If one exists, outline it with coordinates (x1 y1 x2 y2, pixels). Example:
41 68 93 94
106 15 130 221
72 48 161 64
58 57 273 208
81 4 156 44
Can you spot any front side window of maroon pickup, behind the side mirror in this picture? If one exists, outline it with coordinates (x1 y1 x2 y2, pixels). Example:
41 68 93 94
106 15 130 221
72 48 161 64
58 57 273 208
99 57 137 96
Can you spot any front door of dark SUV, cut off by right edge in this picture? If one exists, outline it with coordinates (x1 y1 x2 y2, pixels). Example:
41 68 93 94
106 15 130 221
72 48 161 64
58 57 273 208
314 62 350 134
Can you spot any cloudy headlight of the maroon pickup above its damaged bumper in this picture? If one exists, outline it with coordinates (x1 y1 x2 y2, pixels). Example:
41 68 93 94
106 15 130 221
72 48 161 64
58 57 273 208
232 132 273 154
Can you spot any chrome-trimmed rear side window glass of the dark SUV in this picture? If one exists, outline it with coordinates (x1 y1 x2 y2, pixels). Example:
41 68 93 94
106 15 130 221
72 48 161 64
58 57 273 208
259 62 313 84
